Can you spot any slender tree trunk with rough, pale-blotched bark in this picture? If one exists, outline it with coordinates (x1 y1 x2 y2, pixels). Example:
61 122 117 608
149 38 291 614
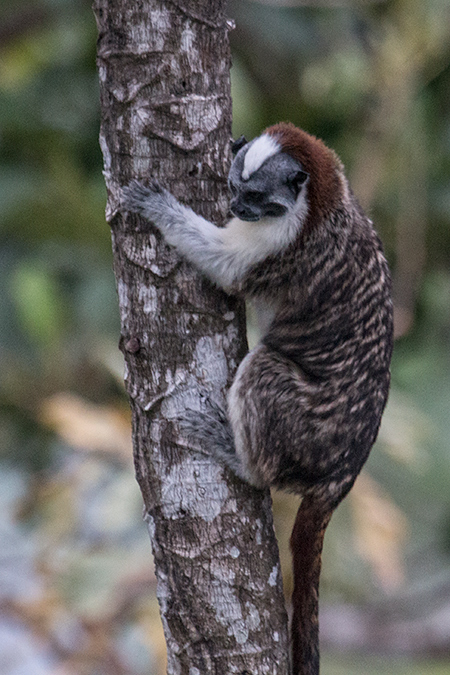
94 0 288 675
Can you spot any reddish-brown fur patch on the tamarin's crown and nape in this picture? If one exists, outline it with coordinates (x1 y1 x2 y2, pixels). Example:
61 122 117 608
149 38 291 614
264 122 342 235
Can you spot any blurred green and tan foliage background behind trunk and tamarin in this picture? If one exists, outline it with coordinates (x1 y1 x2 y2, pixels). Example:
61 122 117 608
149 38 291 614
0 0 450 675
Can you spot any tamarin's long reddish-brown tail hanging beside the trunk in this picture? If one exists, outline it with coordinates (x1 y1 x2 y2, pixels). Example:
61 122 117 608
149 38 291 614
291 496 333 675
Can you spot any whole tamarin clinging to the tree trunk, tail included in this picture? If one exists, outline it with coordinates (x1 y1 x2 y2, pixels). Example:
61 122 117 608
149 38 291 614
123 123 393 675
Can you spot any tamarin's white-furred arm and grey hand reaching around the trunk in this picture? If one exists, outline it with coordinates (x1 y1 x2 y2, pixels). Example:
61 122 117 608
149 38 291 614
122 181 236 288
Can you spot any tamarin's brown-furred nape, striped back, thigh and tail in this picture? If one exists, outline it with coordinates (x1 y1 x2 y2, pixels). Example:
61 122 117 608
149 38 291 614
233 124 393 675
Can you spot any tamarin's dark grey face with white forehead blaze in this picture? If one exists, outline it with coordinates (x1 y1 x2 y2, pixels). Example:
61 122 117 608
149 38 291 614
228 135 308 222
